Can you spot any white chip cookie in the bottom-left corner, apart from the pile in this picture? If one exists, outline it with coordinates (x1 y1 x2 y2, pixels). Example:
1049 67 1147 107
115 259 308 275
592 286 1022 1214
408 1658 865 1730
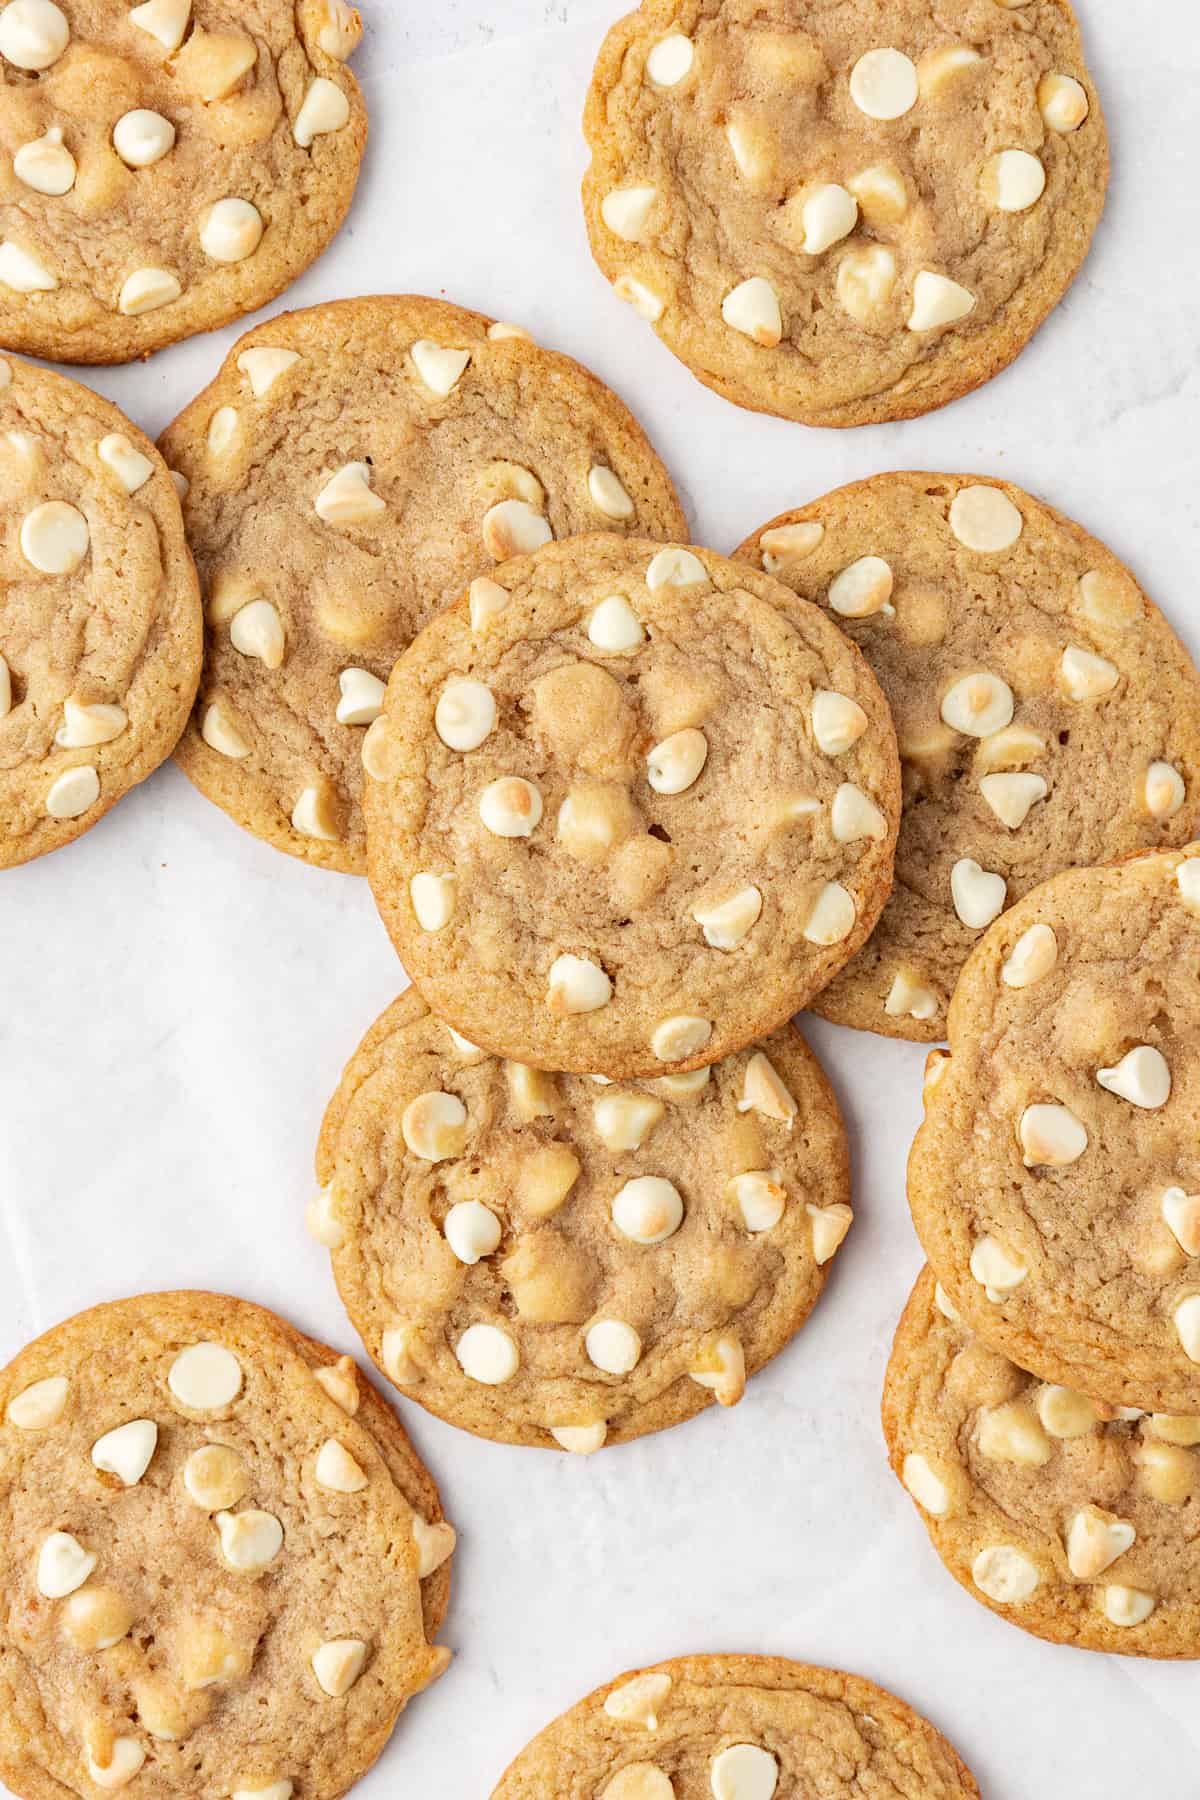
0 1294 453 1800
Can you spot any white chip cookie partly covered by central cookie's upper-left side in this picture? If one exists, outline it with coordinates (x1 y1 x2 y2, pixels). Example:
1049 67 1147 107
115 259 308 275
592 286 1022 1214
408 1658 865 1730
162 297 685 875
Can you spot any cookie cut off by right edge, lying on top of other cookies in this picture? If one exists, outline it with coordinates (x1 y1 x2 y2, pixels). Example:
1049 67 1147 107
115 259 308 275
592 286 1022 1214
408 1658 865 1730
909 844 1200 1413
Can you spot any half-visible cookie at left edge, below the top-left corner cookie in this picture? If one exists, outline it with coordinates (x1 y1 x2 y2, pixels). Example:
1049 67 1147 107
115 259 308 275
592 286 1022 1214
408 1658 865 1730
0 352 201 868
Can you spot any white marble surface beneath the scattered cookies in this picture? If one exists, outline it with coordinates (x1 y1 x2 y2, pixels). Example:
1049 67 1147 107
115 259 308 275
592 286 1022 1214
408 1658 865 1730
0 0 1200 1800
